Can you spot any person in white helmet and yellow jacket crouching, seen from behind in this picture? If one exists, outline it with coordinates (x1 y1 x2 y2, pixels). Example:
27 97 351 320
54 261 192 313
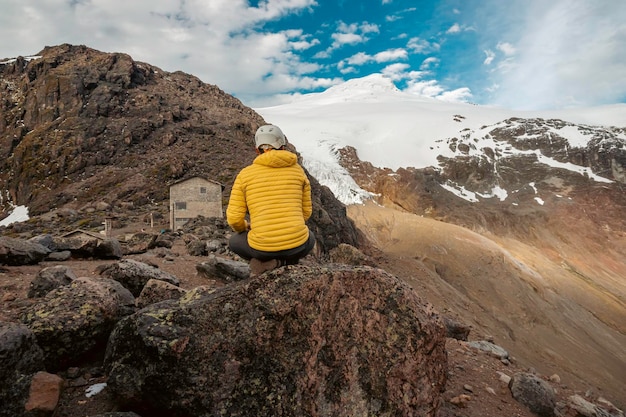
226 125 315 276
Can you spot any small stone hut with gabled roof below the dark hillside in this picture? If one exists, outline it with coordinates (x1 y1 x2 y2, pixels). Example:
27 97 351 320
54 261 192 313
170 176 224 230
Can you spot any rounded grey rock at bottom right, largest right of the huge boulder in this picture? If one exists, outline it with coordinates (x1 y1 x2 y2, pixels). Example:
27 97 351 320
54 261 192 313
509 373 556 417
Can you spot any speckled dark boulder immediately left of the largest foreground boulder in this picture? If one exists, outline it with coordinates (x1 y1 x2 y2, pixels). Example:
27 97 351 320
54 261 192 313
22 277 135 372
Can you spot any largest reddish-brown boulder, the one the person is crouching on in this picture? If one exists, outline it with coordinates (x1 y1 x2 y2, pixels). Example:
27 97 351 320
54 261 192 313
104 265 447 417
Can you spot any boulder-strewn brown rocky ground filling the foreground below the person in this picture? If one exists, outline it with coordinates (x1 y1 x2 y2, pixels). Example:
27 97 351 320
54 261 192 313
0 219 623 417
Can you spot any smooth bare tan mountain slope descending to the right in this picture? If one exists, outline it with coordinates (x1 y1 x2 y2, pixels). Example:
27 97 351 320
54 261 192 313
348 203 626 399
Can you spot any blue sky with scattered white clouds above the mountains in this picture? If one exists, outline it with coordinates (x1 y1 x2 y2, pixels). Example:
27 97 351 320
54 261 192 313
0 0 626 110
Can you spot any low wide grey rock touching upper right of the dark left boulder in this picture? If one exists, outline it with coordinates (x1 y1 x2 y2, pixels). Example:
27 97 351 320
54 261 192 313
100 259 180 297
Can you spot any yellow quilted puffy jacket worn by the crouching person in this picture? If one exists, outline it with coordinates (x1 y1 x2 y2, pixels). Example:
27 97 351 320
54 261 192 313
226 150 312 252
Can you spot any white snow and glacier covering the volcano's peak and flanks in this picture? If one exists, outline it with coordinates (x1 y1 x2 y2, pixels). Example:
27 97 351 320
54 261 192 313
255 74 626 204
